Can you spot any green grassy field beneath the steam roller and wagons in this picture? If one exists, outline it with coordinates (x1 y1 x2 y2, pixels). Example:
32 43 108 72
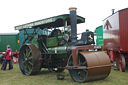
0 64 128 85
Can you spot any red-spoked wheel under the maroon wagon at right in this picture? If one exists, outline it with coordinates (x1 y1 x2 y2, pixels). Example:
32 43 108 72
118 54 126 72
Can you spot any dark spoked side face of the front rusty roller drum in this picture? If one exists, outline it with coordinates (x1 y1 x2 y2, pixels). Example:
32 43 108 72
68 54 88 82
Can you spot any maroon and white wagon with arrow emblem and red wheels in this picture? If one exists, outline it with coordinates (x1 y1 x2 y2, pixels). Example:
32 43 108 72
103 8 128 72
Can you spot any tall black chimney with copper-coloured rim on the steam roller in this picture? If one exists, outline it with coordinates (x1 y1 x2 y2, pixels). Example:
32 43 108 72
69 7 77 42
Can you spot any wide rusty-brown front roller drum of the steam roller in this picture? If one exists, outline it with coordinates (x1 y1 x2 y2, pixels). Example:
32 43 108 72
68 52 111 83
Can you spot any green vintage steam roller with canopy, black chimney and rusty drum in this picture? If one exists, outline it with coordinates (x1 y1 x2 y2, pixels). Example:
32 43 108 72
15 8 111 83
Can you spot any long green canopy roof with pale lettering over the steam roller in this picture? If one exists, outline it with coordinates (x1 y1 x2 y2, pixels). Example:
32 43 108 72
15 14 85 30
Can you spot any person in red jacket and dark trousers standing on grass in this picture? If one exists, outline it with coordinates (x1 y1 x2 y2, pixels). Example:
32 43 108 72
3 45 12 70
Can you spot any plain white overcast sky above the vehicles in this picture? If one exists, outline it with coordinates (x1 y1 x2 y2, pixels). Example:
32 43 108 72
0 0 128 33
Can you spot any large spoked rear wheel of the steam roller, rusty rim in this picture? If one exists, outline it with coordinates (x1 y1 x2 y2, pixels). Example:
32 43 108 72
19 44 41 75
